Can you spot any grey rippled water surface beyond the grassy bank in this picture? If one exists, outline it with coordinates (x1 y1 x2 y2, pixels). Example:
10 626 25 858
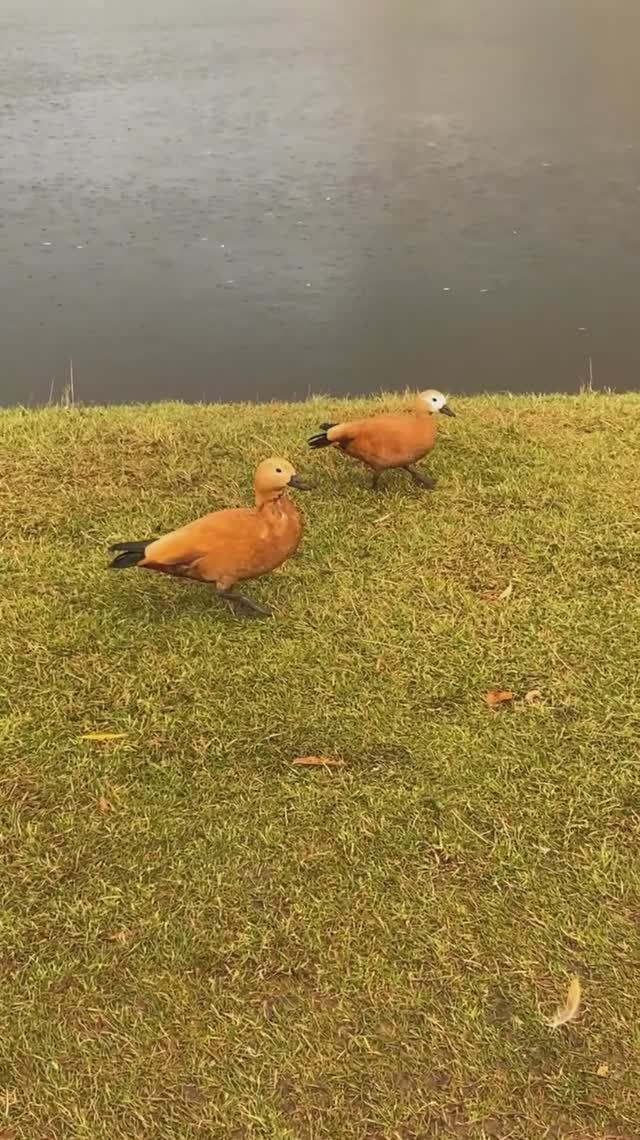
0 0 640 404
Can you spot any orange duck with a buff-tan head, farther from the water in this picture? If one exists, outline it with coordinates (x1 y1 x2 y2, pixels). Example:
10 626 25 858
111 458 308 616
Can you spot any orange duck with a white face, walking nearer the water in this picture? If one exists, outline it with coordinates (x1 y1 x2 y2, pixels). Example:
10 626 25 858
308 388 455 490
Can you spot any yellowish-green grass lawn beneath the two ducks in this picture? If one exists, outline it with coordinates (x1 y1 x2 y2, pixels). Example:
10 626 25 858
0 393 640 1140
